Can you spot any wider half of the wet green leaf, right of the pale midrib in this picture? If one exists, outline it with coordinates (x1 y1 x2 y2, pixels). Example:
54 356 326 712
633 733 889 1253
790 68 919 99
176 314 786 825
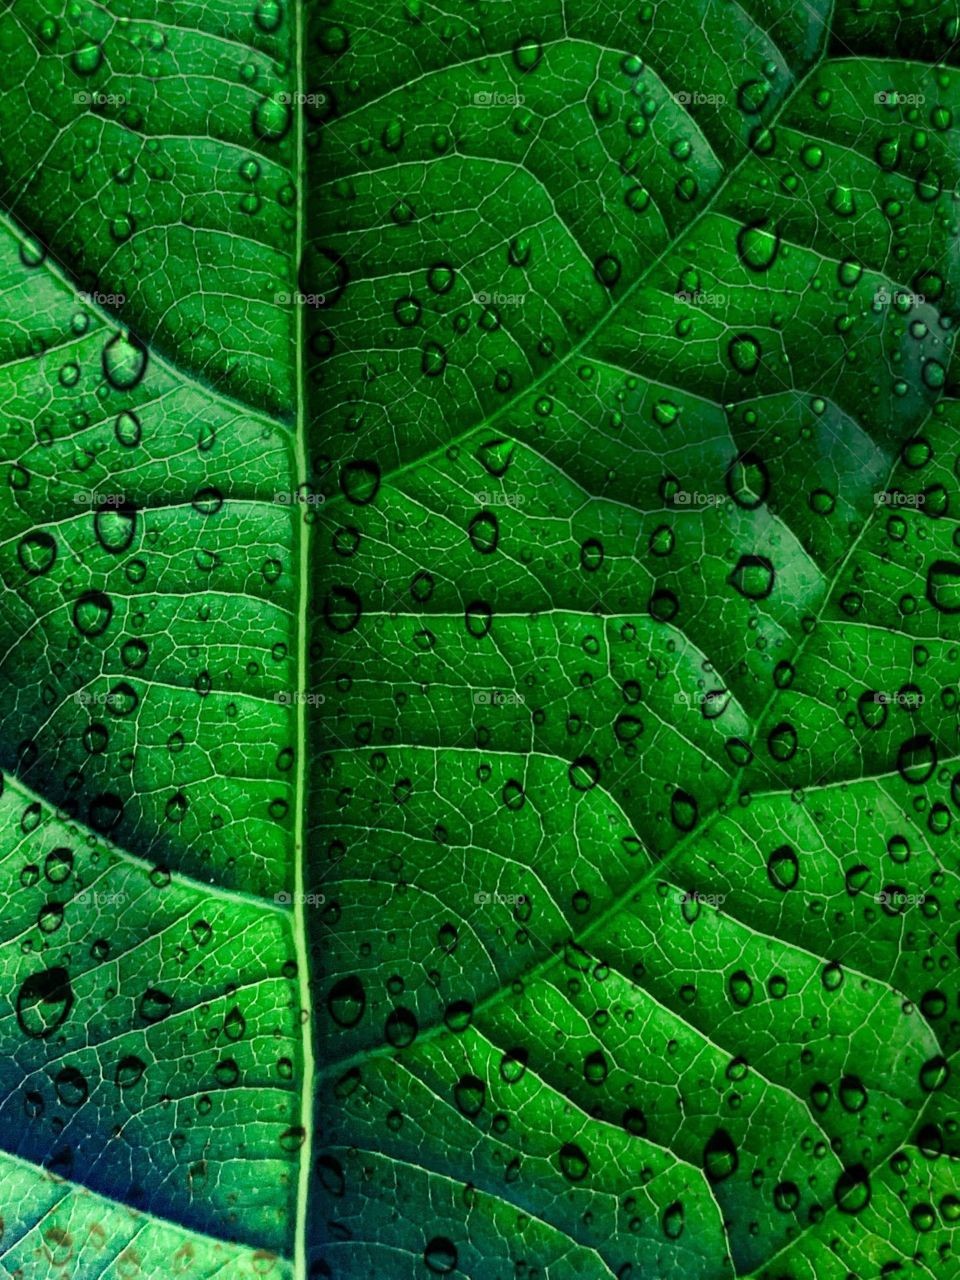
310 0 960 1280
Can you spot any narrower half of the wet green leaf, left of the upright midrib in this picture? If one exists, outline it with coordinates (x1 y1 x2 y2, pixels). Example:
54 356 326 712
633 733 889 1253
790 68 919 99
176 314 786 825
0 3 310 1280
